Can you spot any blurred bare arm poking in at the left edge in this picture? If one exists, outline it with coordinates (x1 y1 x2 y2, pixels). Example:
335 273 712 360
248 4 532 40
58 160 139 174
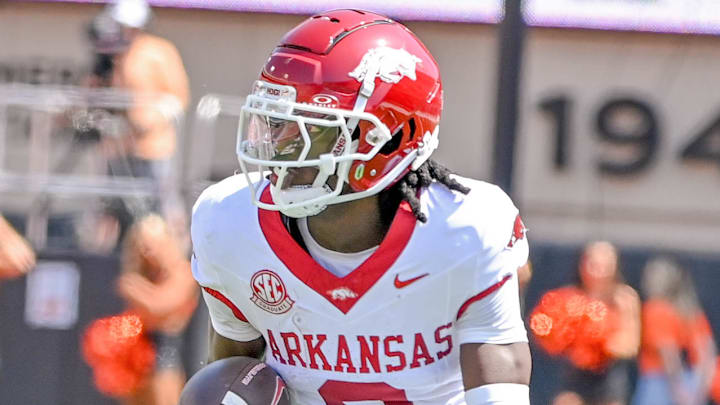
0 211 35 280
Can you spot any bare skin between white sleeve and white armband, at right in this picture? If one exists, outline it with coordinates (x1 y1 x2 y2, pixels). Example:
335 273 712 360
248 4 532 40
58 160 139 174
460 342 532 391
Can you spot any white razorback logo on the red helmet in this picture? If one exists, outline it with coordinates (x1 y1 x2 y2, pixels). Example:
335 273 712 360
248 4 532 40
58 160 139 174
348 46 422 83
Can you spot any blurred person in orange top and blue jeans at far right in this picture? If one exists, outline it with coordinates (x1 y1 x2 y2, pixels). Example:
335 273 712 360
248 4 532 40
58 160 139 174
633 258 716 405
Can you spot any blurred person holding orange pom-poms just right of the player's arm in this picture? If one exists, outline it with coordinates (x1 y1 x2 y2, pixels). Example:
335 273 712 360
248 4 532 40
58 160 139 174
530 241 640 405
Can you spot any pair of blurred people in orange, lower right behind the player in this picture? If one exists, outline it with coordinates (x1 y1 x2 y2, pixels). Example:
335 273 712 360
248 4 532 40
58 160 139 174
528 241 720 405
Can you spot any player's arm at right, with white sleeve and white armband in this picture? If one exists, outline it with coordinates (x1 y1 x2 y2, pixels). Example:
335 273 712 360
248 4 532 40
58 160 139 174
455 188 532 405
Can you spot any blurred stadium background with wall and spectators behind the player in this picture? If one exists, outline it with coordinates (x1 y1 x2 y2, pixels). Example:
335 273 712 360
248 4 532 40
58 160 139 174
0 0 720 405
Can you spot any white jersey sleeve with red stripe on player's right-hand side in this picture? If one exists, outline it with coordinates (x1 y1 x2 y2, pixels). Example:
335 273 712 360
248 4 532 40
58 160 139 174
455 184 529 344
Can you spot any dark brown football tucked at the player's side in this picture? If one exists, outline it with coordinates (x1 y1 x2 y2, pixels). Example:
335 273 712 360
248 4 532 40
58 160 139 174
179 357 290 405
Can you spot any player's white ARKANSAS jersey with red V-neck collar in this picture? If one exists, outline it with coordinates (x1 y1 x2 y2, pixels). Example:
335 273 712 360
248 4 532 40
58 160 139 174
192 176 528 405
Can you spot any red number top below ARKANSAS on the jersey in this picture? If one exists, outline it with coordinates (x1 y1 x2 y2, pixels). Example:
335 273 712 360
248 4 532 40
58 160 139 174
318 380 412 405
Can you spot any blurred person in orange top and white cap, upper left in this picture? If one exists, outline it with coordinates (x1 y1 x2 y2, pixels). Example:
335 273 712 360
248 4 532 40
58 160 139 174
87 0 189 250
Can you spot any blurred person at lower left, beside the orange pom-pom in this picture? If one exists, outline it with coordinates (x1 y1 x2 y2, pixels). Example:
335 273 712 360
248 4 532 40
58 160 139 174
117 215 198 405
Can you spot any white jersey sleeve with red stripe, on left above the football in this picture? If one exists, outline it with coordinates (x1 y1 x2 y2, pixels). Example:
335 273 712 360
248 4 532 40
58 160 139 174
190 192 261 342
